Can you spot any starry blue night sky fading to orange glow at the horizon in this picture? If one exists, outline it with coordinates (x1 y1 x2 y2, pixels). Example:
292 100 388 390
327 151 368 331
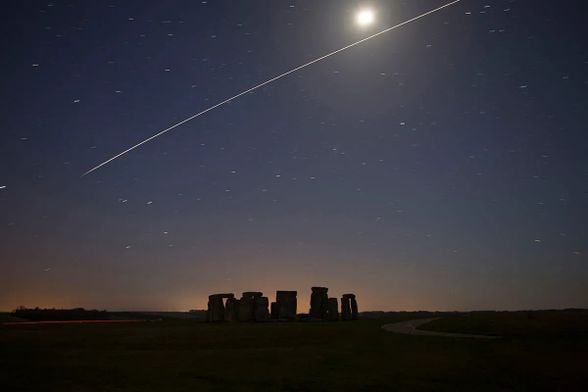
0 0 588 311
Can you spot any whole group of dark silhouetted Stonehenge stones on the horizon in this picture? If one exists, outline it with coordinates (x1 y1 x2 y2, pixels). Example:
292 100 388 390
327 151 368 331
206 287 359 322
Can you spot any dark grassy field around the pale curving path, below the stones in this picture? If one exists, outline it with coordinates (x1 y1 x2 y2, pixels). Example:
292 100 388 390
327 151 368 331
0 311 588 392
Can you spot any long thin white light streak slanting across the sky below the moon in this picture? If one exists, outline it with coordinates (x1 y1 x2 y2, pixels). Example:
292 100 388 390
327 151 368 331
82 0 461 177
